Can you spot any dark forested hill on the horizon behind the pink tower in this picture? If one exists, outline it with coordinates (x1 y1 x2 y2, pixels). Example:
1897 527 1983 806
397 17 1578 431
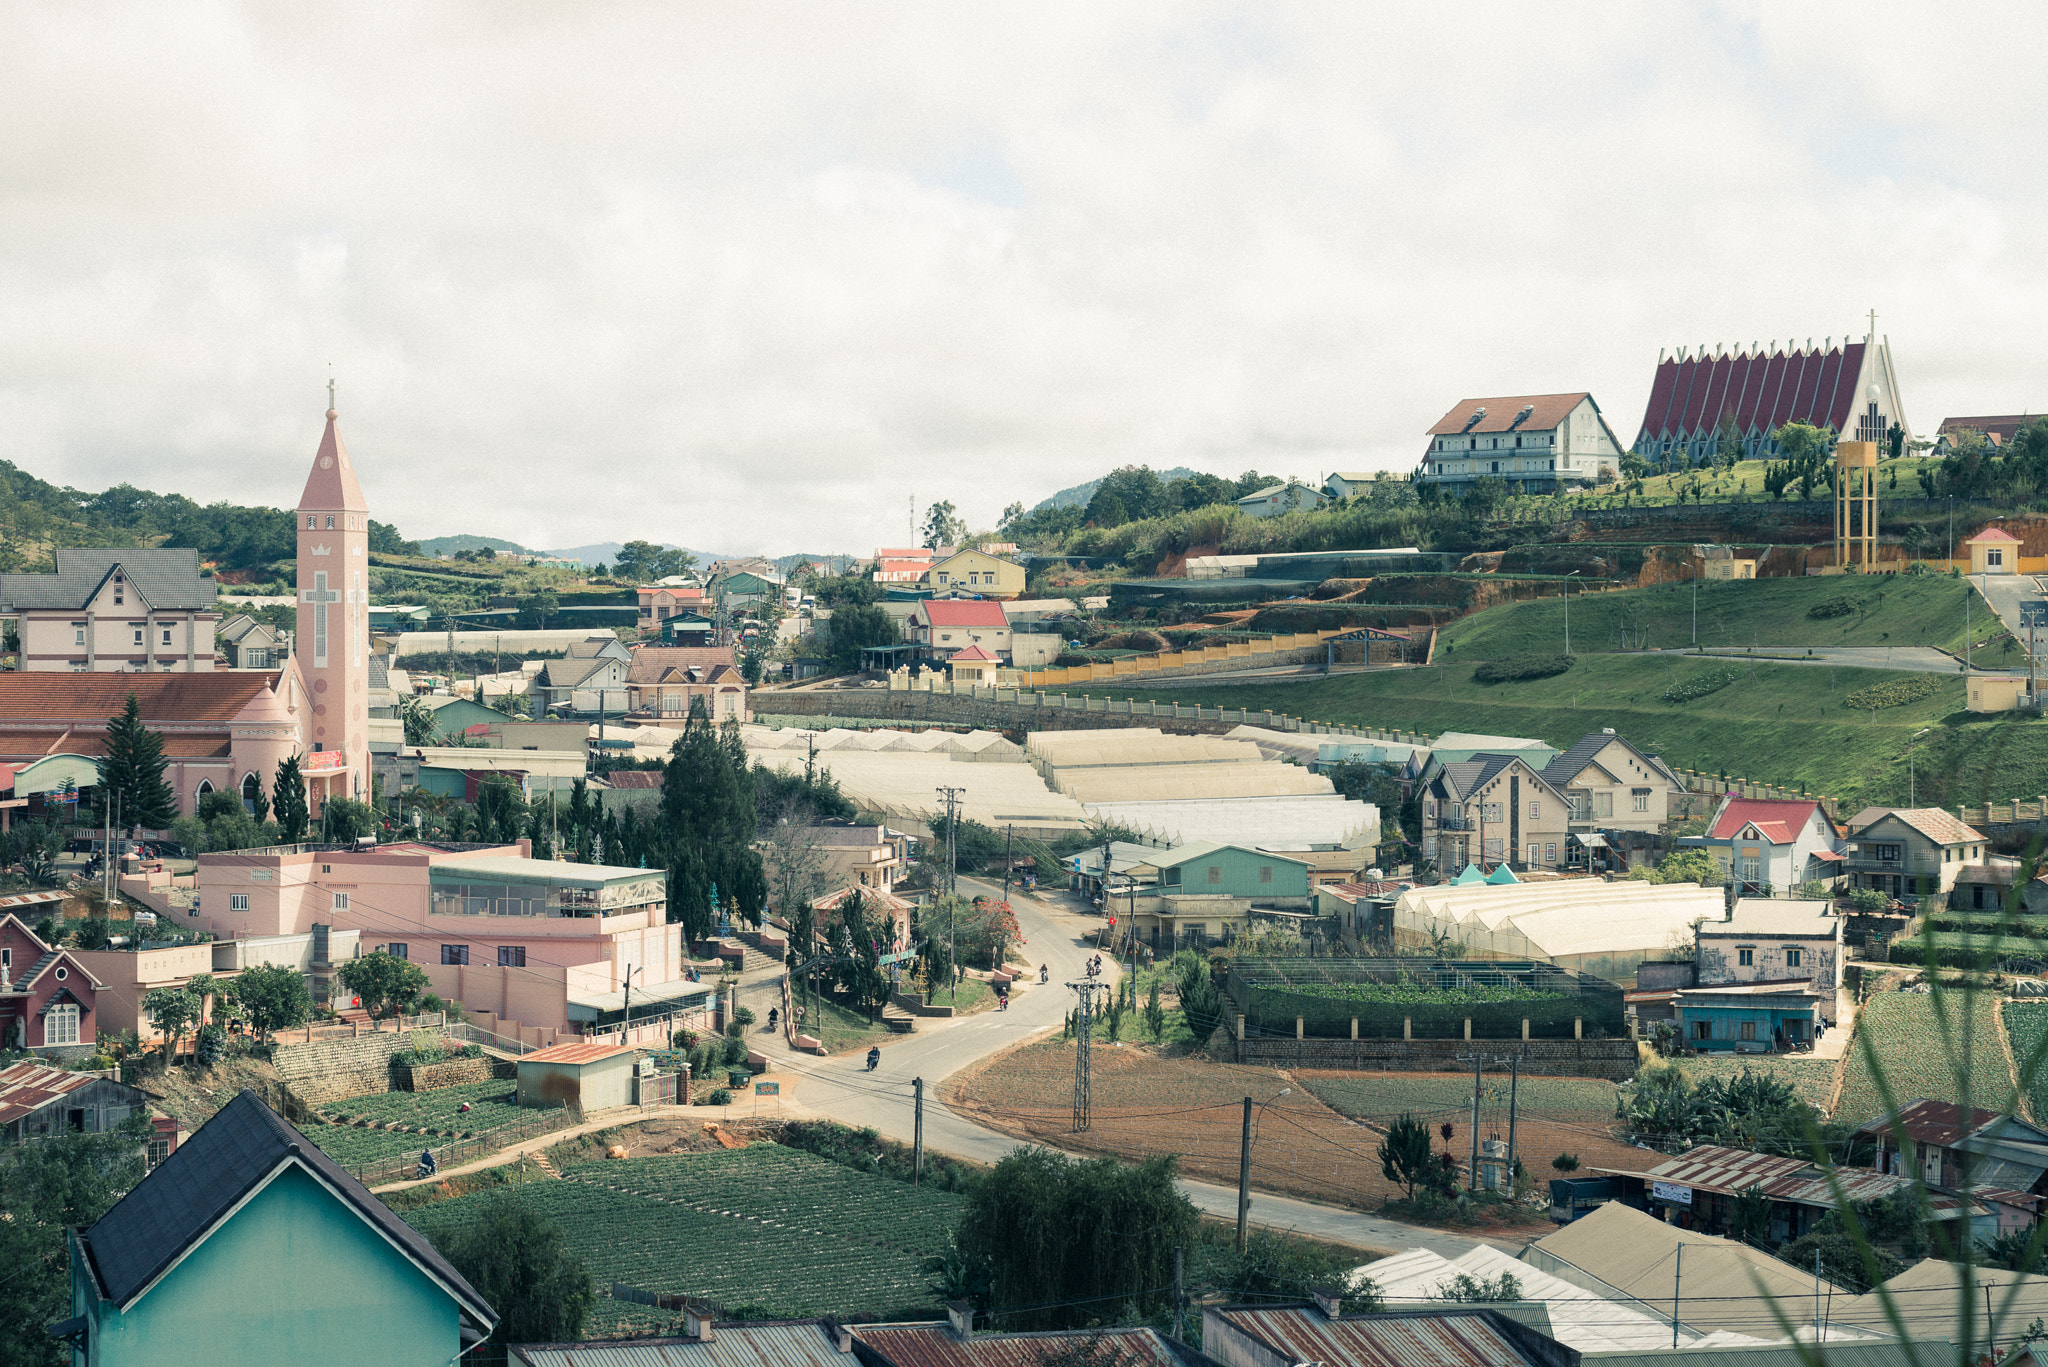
0 461 420 570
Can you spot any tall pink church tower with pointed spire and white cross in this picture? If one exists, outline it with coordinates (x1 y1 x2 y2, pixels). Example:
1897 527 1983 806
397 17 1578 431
295 379 371 810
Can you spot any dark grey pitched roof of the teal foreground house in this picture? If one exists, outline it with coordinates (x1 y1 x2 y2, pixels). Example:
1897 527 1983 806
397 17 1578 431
80 1090 498 1330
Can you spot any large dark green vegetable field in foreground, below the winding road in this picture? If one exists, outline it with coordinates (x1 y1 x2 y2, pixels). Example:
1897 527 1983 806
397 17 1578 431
406 1144 965 1326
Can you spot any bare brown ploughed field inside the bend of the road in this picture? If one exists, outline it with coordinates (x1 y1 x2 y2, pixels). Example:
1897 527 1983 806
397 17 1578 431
944 1039 1661 1209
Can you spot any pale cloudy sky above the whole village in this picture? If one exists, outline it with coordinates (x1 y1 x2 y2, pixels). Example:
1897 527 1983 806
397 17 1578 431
0 0 2048 551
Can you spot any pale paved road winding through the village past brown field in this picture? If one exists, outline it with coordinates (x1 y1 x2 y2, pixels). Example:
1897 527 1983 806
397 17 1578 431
774 877 1522 1258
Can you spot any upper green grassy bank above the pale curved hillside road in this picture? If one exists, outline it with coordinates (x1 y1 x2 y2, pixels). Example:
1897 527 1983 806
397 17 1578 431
1438 574 1999 662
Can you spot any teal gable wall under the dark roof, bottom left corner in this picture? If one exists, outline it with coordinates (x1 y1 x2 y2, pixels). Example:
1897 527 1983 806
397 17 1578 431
72 1168 461 1367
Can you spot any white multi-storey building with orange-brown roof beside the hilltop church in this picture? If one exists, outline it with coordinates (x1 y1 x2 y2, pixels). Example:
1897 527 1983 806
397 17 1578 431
1421 391 1622 494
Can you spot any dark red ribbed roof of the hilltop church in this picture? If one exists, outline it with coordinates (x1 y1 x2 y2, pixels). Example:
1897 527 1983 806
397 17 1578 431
1636 342 1864 441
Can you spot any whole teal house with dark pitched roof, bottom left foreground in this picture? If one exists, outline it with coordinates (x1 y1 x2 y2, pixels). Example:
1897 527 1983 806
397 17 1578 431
49 1092 498 1367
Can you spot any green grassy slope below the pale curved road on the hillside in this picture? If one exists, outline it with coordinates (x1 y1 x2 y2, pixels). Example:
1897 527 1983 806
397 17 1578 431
1087 651 2048 810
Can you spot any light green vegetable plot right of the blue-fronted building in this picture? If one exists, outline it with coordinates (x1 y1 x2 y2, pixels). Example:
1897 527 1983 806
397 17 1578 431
1835 992 2013 1125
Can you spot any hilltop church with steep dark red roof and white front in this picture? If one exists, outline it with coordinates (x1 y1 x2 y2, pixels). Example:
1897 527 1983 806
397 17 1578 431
1632 321 1913 467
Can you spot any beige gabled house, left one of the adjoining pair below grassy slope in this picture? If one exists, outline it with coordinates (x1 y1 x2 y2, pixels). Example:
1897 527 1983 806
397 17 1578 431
1421 754 1571 873
